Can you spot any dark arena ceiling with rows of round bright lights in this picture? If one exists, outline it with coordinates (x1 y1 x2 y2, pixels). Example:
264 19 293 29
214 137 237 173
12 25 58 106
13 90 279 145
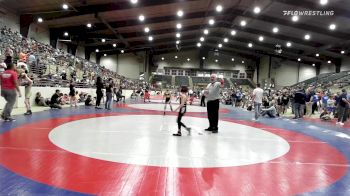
0 0 350 63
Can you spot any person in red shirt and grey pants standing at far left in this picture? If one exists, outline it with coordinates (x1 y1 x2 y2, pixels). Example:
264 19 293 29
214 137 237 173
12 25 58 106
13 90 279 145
0 63 22 121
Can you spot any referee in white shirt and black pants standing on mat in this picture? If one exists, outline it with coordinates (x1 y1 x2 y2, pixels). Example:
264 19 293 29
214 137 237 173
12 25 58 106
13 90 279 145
205 74 224 133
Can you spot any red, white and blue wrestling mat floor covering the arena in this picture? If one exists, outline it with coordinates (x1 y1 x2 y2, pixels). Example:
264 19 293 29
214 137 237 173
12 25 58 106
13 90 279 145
0 97 350 196
